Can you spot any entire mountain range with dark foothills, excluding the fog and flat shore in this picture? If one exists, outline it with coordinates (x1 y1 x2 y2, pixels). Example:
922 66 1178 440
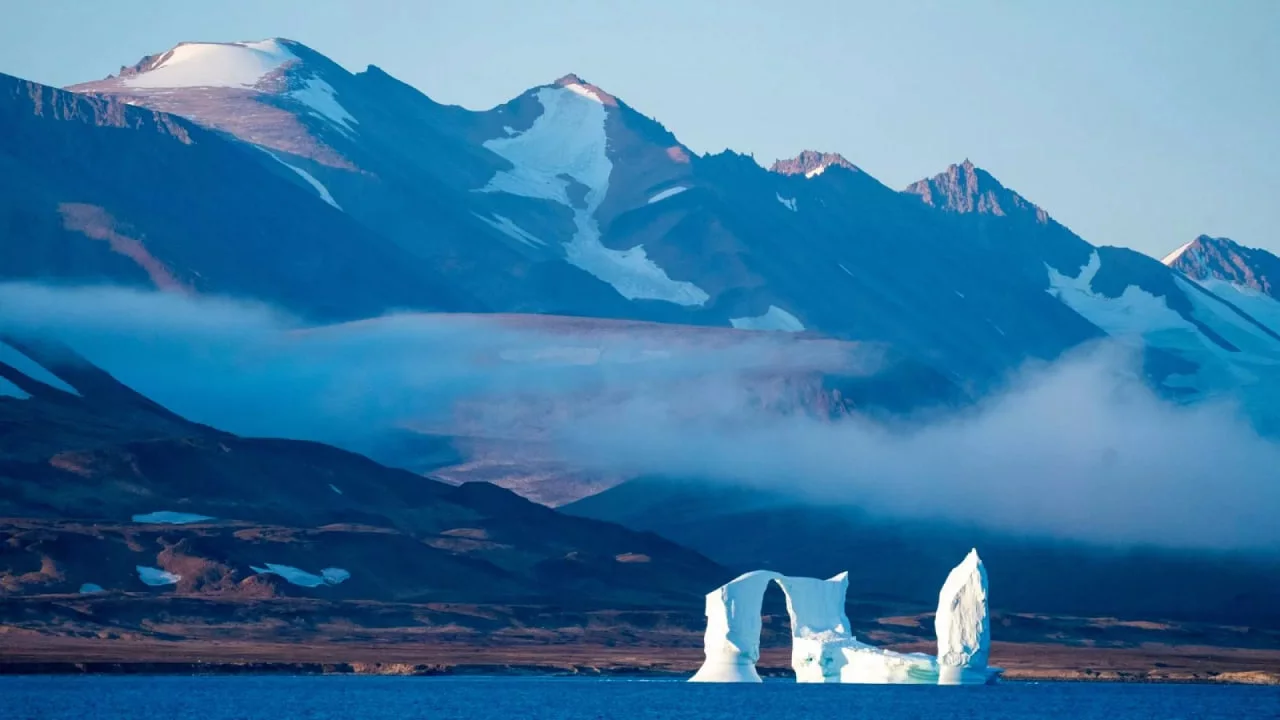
0 38 1280 645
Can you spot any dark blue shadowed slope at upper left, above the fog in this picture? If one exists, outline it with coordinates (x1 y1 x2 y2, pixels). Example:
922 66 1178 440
0 76 474 318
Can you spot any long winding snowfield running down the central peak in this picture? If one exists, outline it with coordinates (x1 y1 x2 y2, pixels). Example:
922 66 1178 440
481 86 710 306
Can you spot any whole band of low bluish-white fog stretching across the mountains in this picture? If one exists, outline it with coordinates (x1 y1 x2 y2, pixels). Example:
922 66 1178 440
0 284 1280 550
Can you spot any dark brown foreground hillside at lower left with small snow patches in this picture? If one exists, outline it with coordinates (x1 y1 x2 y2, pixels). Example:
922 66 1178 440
0 341 727 609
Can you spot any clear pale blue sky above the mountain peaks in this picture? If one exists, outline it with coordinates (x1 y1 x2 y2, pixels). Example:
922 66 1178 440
0 0 1280 256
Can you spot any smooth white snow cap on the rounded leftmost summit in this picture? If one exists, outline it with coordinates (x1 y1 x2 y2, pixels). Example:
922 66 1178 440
123 40 297 88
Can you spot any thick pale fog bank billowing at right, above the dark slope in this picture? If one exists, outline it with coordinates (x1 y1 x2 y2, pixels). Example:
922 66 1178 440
562 343 1280 550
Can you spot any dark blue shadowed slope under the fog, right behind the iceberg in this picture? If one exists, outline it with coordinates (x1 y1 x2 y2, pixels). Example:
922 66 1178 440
564 478 1280 628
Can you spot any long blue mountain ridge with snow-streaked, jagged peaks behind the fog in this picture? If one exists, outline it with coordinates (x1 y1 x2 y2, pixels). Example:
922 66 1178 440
55 40 1280 425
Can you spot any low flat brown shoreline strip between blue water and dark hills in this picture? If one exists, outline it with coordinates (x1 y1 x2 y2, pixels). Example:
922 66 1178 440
0 635 1280 685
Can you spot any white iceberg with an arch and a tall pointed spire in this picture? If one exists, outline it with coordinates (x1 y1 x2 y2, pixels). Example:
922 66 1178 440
691 550 1000 685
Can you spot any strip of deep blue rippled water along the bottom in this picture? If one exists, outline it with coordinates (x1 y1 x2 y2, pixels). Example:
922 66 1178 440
0 676 1280 720
